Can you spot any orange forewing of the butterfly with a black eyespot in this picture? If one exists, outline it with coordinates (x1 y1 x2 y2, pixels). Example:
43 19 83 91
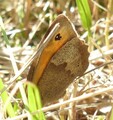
28 15 77 84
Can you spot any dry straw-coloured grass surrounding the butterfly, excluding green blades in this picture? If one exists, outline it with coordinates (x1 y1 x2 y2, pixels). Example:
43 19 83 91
0 0 113 120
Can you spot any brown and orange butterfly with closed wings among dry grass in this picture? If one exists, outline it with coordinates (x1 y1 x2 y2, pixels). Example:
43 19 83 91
27 14 89 105
